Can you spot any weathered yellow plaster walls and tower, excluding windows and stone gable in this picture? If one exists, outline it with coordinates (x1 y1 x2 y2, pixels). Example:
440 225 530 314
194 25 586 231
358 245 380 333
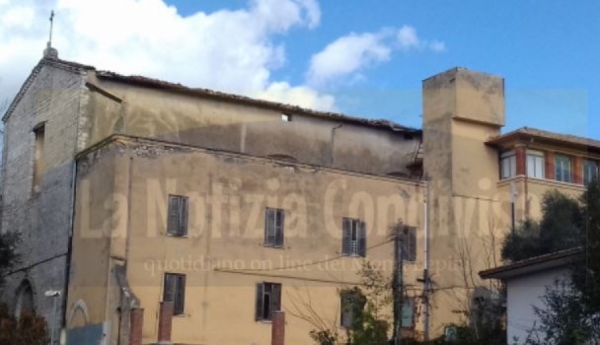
59 65 600 345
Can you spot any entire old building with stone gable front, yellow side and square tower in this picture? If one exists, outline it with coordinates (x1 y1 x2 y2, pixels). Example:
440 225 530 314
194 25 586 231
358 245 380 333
2 46 600 345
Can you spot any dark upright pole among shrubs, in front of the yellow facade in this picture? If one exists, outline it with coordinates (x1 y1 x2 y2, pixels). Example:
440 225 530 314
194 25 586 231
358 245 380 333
392 222 404 345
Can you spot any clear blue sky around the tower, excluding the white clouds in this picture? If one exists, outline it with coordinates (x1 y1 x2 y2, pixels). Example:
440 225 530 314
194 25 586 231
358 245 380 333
169 0 600 139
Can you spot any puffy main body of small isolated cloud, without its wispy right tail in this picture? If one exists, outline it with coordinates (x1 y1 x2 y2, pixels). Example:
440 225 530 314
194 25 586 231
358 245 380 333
307 32 391 85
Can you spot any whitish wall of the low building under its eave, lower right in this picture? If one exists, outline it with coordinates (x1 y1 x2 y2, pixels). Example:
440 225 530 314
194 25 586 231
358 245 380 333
506 268 569 345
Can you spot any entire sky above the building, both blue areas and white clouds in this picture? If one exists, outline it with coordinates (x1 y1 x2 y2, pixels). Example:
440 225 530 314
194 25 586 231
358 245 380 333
0 0 600 139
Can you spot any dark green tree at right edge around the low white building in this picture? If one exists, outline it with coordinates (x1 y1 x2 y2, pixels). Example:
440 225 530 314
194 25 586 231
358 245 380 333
513 180 600 345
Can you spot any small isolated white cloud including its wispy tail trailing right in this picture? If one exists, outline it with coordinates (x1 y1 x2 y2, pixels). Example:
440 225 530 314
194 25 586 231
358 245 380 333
306 25 446 87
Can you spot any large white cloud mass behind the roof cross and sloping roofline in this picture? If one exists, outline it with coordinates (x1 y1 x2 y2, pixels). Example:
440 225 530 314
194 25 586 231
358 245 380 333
0 0 335 109
